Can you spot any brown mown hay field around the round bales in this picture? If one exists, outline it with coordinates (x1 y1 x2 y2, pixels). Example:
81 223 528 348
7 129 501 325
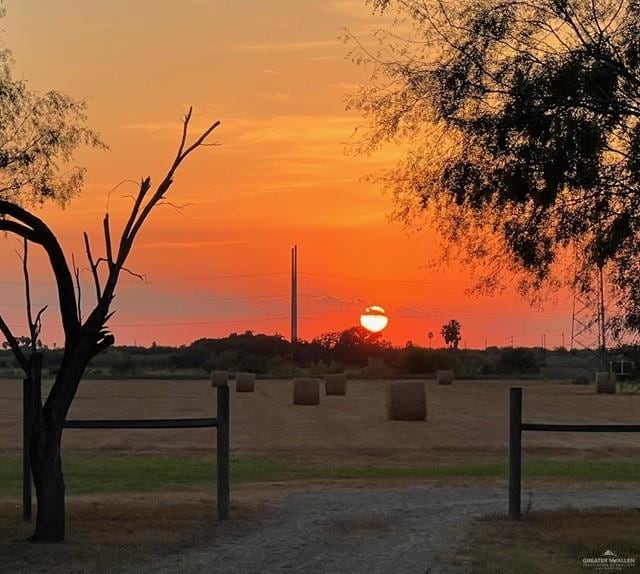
0 380 640 463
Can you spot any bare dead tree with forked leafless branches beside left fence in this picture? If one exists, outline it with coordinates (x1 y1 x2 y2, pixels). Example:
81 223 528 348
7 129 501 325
0 108 220 542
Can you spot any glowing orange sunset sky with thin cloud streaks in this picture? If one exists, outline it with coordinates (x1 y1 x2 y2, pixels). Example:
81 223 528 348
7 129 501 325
0 0 571 348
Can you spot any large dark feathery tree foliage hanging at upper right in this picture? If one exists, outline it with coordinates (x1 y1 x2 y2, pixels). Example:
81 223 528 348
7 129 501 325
350 0 640 338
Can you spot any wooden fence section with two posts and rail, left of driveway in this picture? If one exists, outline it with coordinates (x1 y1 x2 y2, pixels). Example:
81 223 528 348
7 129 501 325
22 380 230 521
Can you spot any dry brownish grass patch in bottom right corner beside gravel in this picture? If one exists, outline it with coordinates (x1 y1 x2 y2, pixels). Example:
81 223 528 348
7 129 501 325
469 510 640 574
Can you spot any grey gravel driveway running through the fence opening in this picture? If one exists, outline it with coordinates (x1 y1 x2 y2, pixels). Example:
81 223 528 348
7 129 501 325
141 486 640 574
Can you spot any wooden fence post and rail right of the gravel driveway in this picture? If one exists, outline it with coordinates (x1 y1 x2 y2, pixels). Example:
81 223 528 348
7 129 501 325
509 387 640 520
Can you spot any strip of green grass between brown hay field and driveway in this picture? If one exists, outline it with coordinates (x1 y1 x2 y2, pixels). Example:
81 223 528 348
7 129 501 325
0 455 640 498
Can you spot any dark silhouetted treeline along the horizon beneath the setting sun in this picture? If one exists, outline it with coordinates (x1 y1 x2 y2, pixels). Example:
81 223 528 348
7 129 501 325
0 327 640 378
